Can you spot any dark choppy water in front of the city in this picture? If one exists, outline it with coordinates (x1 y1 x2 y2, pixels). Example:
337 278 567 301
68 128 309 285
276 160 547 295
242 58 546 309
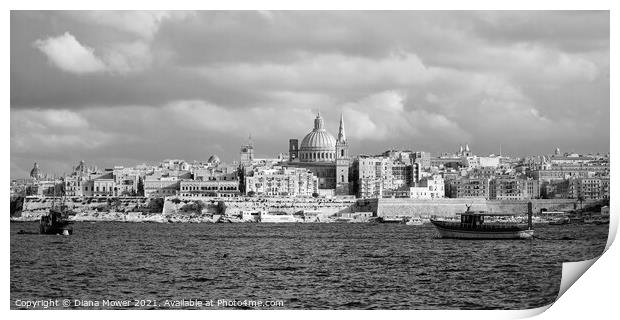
10 222 608 309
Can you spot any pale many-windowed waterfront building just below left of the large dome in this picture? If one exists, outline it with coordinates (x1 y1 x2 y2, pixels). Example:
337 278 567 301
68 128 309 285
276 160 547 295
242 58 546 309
245 166 319 197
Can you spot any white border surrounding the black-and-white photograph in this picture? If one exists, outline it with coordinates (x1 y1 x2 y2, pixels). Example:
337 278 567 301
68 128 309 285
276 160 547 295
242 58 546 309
0 0 620 319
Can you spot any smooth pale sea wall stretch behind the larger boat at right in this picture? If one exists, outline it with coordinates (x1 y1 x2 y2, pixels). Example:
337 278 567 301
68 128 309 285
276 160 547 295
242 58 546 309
377 198 598 216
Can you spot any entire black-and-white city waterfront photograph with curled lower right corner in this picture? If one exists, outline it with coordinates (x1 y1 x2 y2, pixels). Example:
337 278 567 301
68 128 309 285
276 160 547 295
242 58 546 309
8 10 614 314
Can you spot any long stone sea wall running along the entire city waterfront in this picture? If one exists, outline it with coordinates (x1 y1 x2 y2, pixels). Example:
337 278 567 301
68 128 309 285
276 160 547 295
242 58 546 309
11 196 600 222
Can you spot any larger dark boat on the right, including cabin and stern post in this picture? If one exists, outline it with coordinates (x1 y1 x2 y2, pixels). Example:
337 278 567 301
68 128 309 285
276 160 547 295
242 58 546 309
431 206 534 239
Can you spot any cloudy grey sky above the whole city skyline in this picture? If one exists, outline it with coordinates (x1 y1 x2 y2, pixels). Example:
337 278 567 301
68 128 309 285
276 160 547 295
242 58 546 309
10 11 610 178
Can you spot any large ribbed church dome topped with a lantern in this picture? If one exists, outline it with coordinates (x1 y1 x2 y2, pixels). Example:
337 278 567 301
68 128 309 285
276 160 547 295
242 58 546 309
299 113 336 162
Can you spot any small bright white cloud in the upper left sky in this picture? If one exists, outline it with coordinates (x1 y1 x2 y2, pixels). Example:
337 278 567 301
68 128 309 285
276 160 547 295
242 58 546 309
34 32 106 74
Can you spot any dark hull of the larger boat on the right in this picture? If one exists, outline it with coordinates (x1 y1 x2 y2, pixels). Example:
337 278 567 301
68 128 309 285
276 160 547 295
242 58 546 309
431 220 534 240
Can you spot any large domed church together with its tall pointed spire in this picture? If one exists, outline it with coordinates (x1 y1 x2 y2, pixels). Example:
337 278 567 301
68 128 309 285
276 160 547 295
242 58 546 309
288 112 350 196
